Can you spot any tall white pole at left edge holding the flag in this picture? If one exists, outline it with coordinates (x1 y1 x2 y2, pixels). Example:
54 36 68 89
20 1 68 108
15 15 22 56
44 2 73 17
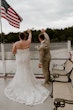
0 0 6 76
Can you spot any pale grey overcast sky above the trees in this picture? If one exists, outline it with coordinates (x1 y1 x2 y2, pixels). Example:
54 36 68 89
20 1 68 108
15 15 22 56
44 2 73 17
2 0 73 33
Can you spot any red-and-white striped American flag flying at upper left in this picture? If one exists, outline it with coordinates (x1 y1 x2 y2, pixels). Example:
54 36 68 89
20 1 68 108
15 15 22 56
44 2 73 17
1 0 22 28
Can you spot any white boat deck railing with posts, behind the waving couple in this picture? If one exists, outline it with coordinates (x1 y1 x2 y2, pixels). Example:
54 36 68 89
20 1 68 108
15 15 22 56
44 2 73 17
0 41 71 74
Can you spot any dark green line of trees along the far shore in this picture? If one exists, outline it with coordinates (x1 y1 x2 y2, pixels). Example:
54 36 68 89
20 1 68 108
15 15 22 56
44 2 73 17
0 26 73 44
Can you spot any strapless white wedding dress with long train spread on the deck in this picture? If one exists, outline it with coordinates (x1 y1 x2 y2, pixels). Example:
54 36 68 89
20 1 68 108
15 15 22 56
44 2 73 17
4 49 49 105
